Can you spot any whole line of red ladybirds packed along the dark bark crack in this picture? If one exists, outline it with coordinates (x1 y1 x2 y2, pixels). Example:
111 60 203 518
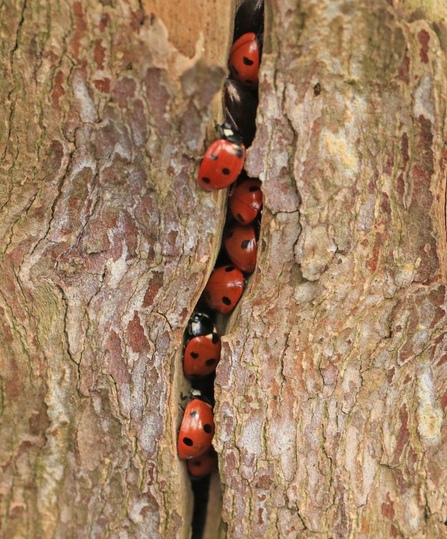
177 0 264 478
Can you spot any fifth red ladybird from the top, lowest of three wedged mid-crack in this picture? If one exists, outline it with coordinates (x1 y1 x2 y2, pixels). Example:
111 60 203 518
203 265 245 314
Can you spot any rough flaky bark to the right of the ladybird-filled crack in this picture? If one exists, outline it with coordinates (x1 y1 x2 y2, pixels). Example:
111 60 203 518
216 0 447 539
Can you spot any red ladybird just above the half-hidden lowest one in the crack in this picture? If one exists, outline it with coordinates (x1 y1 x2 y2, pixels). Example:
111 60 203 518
177 398 215 460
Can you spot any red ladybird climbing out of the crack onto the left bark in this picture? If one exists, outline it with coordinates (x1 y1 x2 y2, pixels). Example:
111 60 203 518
197 124 245 191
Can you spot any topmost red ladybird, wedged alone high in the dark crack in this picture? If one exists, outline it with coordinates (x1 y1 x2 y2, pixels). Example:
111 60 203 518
228 32 261 88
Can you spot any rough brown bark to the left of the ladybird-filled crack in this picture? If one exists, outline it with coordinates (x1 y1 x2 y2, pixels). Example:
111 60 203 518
0 0 231 539
